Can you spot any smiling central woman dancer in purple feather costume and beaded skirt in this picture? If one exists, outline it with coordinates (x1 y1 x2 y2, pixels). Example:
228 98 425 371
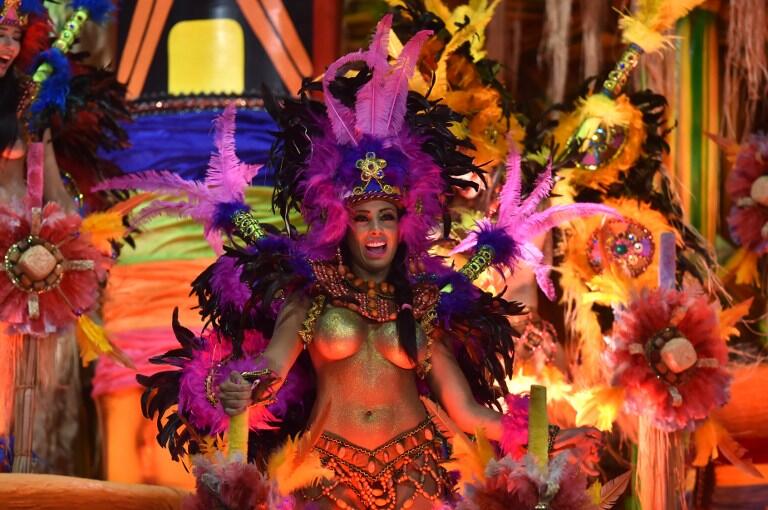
124 16 609 509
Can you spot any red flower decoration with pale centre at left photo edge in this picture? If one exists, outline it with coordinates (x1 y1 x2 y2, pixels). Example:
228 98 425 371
0 203 113 335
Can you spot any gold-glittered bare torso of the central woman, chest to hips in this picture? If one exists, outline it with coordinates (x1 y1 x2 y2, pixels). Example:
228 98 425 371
309 308 426 449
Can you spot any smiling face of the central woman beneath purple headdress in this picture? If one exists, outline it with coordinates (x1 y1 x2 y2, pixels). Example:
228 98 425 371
347 200 399 281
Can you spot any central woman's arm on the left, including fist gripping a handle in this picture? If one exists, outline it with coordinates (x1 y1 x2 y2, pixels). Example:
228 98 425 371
219 295 311 416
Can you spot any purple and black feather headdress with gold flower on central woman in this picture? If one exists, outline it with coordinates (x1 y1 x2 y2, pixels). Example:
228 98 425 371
267 15 479 259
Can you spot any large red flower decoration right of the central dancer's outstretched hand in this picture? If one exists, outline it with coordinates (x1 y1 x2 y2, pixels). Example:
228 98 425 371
607 289 731 432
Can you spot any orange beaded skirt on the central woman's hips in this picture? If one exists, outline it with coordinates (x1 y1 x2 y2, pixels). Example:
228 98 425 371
303 418 453 510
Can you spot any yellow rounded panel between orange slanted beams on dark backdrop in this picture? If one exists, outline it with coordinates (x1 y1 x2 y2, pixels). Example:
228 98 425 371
168 18 245 95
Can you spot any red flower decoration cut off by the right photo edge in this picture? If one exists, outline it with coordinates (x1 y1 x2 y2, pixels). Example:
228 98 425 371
725 135 768 255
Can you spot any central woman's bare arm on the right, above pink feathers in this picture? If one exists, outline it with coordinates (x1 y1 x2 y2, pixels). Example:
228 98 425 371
427 336 502 441
